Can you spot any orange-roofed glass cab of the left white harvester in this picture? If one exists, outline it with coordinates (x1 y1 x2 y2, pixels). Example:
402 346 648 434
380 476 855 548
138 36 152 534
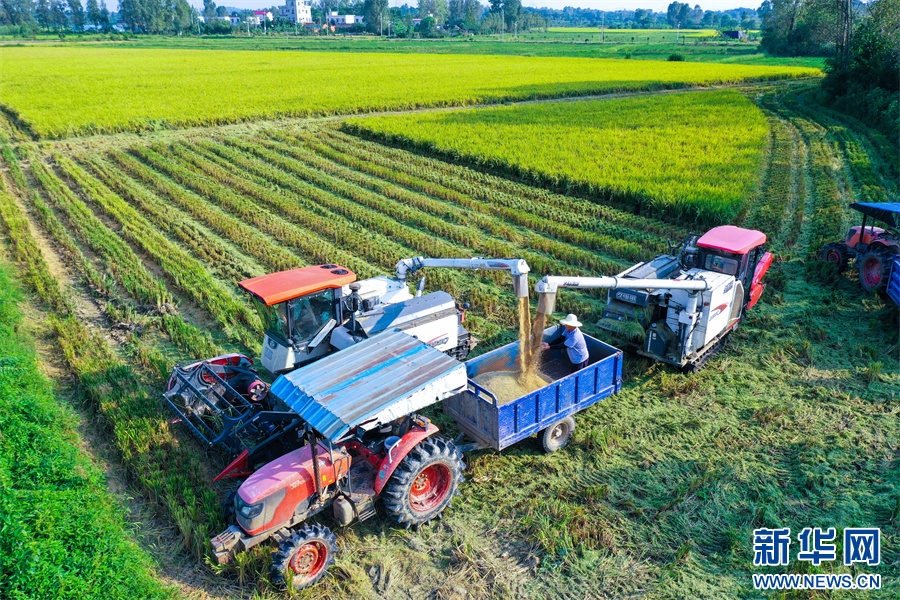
238 265 356 374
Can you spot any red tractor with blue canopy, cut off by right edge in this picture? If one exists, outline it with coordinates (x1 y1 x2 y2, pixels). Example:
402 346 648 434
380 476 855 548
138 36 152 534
821 202 900 292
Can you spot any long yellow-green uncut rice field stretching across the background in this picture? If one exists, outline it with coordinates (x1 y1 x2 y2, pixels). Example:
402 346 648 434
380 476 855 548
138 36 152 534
0 47 818 137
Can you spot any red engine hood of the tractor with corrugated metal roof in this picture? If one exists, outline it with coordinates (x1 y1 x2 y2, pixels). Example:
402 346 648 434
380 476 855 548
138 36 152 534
238 443 350 535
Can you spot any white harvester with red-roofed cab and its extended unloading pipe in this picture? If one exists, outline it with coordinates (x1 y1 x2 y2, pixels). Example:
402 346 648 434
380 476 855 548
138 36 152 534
535 225 772 372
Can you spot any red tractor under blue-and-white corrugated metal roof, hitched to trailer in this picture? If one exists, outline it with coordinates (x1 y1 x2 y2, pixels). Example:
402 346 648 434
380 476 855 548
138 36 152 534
198 329 468 589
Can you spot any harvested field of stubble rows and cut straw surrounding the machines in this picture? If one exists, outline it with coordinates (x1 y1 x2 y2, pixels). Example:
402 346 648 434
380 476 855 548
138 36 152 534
0 87 900 600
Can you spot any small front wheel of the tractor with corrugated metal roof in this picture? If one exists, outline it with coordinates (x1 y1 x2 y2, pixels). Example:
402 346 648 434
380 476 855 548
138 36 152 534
271 525 338 590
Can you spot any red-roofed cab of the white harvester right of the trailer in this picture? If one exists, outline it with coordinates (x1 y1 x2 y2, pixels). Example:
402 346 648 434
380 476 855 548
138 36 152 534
686 225 772 310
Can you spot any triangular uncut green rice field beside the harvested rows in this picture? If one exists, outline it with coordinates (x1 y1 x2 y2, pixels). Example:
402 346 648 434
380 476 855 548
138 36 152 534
347 90 767 224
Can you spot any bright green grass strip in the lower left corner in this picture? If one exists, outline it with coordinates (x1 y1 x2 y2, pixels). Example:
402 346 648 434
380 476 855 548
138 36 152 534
0 258 174 600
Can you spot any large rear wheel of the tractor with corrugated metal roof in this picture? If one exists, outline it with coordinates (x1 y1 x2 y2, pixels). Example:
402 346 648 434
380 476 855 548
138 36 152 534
383 437 466 529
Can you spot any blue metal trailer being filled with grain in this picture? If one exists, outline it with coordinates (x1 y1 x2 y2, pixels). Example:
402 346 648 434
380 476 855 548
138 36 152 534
444 327 622 451
